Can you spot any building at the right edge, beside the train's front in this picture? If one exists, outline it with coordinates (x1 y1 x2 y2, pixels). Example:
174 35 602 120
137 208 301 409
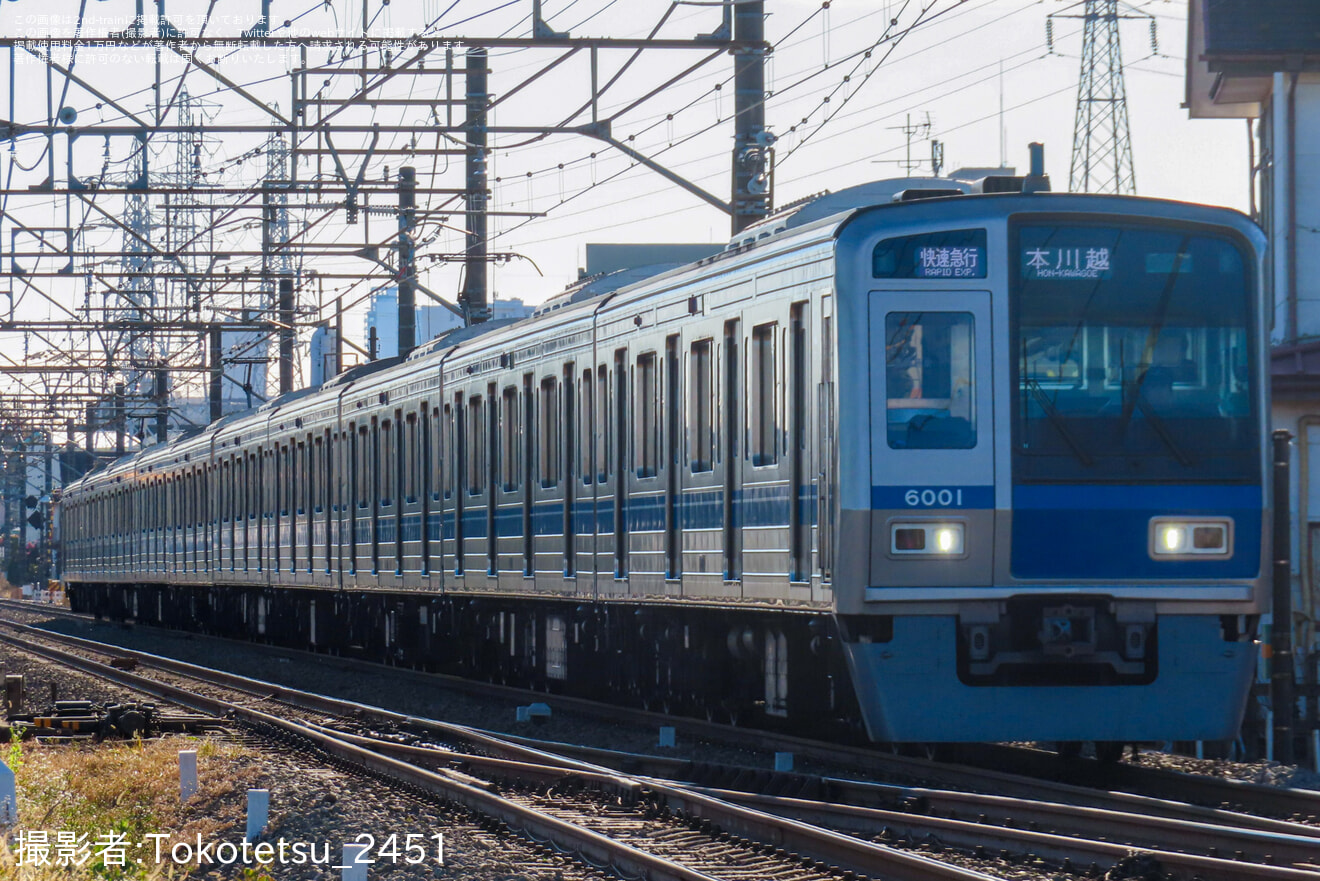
1185 0 1320 668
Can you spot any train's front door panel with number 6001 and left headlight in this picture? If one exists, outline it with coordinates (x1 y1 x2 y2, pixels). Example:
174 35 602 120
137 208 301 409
870 291 994 589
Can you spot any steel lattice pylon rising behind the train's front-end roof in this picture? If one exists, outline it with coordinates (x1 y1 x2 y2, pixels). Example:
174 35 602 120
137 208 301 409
1048 0 1155 194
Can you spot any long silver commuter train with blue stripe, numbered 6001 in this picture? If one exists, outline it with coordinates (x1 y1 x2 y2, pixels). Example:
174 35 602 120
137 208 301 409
59 167 1271 749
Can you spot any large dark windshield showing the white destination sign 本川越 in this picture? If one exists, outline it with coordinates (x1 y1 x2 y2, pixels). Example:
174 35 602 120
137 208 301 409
1011 226 1259 482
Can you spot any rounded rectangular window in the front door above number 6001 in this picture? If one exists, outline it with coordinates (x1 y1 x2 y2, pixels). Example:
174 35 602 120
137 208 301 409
884 312 977 449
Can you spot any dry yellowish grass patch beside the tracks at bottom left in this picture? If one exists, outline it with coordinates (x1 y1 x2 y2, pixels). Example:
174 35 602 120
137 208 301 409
0 737 268 881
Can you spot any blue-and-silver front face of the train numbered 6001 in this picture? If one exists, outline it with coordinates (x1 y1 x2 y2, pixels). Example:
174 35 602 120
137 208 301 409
836 195 1269 742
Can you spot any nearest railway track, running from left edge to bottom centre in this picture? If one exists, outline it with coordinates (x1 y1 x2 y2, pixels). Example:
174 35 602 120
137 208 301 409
0 622 991 881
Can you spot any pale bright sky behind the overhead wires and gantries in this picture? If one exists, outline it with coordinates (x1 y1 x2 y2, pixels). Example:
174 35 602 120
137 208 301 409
0 0 1247 393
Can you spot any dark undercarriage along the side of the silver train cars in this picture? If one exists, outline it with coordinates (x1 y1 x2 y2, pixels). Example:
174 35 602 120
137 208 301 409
69 584 861 737
